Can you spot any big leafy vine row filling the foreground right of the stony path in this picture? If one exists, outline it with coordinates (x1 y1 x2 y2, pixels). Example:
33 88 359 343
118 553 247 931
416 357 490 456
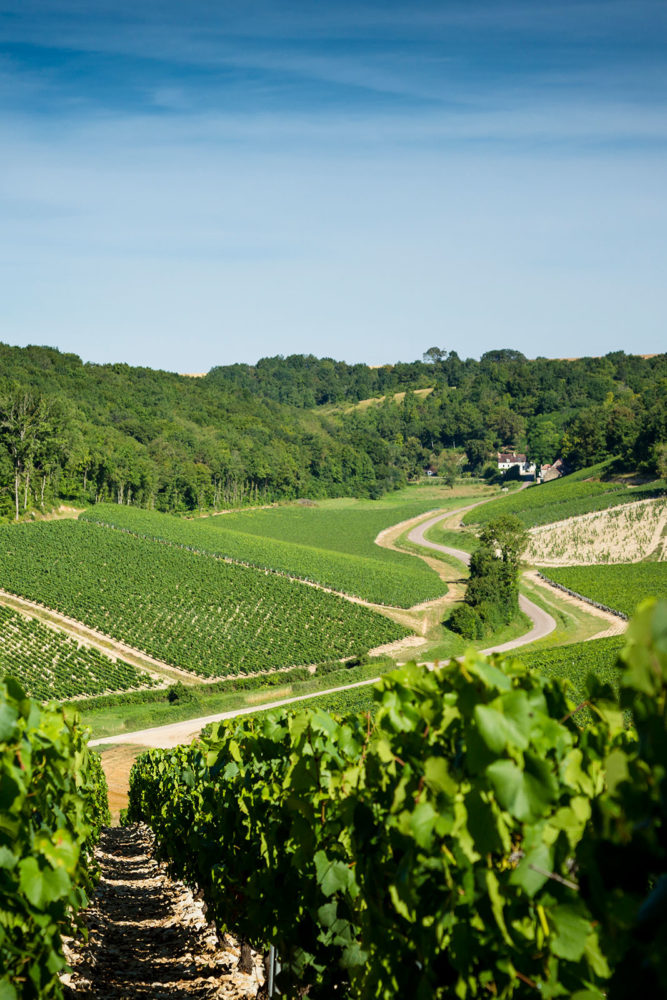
128 606 667 1000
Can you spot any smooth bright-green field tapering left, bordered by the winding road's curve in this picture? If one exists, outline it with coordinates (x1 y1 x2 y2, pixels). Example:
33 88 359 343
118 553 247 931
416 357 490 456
82 491 474 608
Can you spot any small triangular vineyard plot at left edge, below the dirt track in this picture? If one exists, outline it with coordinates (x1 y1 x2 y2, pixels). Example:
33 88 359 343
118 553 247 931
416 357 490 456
0 607 157 701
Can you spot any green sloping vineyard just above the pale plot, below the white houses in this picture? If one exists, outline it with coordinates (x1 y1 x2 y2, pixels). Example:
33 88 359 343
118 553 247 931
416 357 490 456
463 466 666 528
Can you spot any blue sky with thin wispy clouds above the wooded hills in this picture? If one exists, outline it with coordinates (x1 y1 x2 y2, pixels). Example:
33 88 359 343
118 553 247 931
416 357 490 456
0 0 667 371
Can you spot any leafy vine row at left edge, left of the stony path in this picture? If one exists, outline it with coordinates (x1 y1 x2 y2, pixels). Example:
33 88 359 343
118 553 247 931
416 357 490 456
0 679 110 1000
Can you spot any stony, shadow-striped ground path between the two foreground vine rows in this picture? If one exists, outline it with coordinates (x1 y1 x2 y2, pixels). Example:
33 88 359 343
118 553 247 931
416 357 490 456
64 825 263 1000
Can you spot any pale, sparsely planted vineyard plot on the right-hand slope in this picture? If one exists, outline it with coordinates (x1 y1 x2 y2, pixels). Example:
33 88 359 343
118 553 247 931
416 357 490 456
526 498 667 566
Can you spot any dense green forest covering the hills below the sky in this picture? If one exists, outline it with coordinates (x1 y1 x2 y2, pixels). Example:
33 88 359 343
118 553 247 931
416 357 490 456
0 344 667 518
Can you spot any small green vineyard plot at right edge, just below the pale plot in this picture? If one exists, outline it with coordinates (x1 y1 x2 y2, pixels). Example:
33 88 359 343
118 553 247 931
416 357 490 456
545 562 667 616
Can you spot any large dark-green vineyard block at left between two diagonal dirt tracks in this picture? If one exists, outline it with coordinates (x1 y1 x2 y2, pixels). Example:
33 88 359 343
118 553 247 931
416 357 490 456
0 521 409 676
